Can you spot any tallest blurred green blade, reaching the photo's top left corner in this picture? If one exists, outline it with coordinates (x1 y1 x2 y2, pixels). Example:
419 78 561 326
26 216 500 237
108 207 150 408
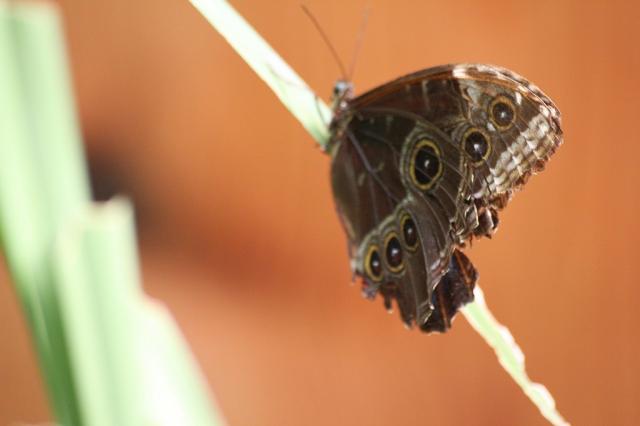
0 2 89 424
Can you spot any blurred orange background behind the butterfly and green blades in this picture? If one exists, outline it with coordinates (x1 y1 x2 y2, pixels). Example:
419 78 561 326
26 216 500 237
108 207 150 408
0 0 640 426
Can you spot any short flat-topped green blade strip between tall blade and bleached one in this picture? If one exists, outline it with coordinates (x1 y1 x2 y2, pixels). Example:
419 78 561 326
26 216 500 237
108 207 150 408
53 200 145 426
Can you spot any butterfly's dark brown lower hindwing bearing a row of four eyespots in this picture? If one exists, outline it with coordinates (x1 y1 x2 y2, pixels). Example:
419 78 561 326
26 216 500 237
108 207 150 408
332 110 472 325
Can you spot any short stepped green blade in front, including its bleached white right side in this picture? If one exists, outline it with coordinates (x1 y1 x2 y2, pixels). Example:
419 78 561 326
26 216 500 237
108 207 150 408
54 199 223 426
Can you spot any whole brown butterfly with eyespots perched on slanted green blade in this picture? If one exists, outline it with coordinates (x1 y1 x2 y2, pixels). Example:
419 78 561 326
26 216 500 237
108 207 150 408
327 64 562 332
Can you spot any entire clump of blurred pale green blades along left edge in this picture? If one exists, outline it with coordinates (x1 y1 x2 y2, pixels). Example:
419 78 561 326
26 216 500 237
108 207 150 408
0 4 223 426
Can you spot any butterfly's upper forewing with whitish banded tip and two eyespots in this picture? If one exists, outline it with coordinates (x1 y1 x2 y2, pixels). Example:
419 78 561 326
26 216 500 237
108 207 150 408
349 64 562 238
